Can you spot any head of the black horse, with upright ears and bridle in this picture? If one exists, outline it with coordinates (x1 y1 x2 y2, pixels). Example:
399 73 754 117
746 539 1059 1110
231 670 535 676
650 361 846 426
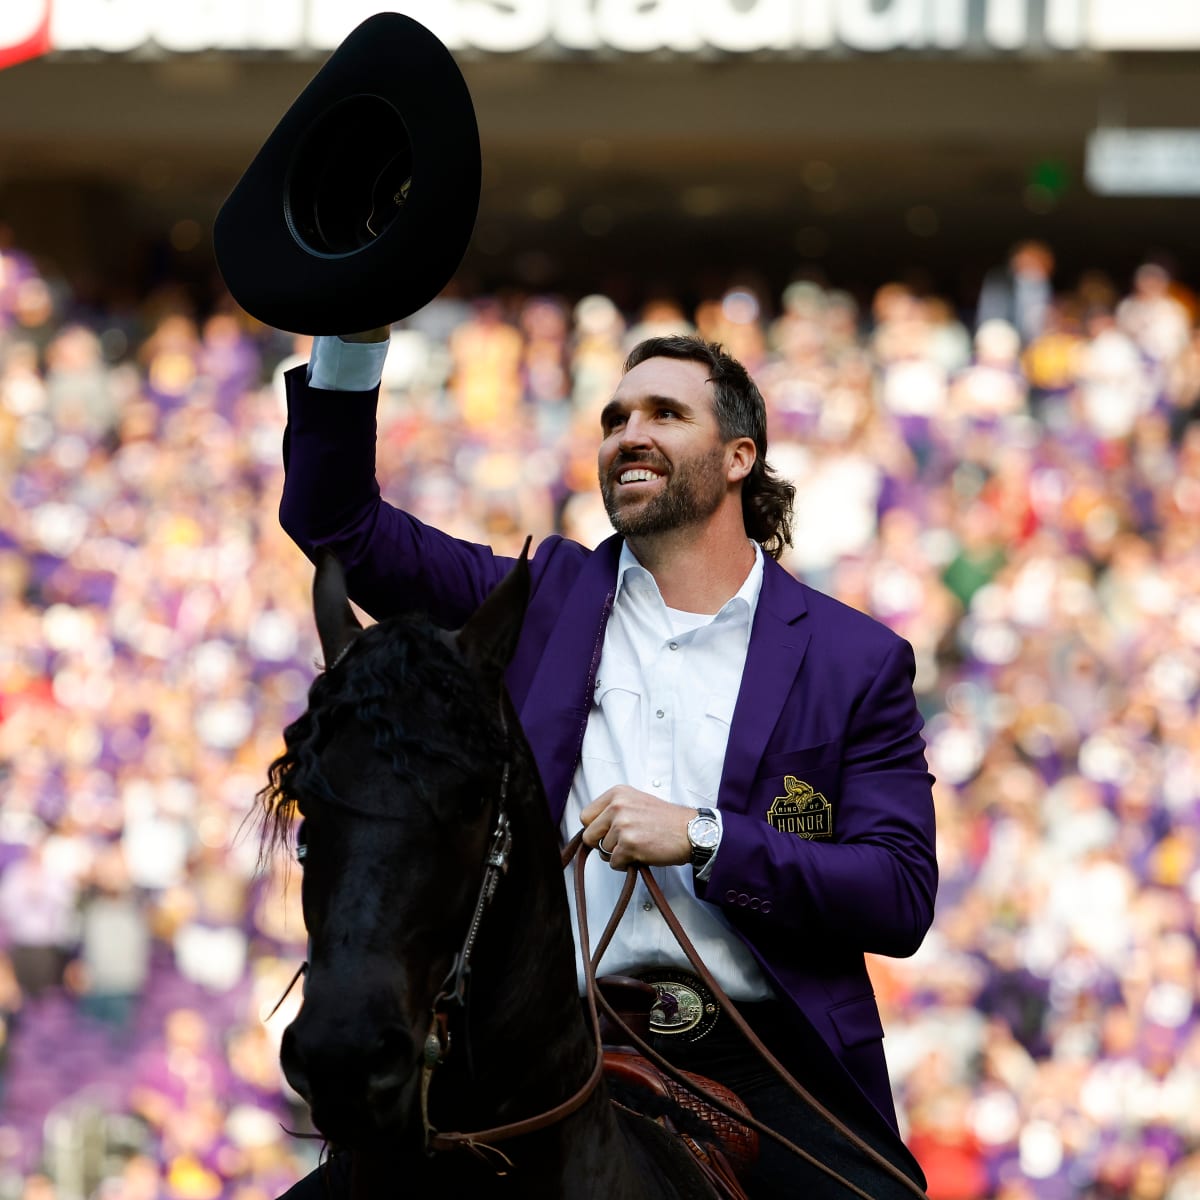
264 553 562 1145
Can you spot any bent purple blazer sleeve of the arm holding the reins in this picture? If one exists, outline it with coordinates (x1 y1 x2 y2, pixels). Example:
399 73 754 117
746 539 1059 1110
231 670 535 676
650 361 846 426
697 637 937 958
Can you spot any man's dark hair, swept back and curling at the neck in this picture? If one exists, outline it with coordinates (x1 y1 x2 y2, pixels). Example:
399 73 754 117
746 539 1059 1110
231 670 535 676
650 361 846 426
624 334 796 559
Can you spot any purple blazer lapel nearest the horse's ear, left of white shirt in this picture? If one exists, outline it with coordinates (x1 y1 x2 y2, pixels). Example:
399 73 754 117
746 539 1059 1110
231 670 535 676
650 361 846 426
520 538 622 822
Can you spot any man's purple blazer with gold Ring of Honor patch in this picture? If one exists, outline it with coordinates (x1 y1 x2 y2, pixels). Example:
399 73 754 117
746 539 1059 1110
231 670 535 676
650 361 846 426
280 367 937 1129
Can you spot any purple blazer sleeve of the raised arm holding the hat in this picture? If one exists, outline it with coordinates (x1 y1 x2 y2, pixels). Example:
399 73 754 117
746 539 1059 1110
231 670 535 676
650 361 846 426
280 366 512 629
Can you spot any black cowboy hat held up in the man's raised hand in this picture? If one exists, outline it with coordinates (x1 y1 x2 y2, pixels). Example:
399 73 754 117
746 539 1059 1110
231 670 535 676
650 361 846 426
212 12 480 334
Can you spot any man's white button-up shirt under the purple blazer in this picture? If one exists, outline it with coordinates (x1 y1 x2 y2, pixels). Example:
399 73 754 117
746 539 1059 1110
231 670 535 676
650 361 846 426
562 544 772 1001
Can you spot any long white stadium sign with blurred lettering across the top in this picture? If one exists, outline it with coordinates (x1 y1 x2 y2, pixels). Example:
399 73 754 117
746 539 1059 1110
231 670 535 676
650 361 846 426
0 0 1200 66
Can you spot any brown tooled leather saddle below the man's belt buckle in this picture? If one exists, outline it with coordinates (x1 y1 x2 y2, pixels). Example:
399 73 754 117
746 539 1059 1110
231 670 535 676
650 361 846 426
596 976 758 1200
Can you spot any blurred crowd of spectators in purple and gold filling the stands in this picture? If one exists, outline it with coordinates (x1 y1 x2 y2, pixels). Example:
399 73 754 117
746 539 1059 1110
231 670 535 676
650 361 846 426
0 229 1200 1200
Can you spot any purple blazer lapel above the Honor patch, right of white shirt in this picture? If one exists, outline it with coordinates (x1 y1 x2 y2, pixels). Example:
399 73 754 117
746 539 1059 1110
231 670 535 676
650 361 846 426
718 558 809 812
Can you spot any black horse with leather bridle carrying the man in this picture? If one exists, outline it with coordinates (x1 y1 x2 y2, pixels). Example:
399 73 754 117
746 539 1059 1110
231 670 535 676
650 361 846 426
262 557 714 1200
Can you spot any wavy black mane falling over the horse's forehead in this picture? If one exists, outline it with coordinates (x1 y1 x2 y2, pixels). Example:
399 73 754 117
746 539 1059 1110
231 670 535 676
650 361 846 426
256 614 505 862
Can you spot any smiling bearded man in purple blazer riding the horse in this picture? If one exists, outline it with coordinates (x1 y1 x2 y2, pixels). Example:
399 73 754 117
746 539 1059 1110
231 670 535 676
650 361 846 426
281 328 937 1198
